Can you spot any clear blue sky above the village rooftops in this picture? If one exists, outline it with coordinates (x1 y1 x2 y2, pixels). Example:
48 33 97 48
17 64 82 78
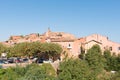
0 0 120 42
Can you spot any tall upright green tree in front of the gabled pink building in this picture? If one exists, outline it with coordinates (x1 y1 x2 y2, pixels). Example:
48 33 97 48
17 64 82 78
85 45 104 77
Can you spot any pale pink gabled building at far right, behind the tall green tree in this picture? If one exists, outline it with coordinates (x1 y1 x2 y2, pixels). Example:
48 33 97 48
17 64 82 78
84 34 120 55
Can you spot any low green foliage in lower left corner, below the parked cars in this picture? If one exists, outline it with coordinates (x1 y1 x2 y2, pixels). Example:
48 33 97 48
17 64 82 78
0 64 56 80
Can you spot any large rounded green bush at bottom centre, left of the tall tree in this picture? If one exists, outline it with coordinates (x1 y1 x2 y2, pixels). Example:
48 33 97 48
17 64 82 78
58 59 90 80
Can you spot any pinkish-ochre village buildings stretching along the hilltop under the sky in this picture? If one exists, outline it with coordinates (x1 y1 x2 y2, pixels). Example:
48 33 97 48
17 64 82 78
2 29 120 57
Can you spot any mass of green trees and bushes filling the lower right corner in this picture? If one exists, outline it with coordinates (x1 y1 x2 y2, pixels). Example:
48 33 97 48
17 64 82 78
58 45 120 80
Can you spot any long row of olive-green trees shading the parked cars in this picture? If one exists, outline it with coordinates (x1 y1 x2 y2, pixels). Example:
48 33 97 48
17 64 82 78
0 42 62 59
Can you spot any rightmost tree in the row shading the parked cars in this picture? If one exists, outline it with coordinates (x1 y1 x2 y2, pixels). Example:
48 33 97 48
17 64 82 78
35 43 62 60
